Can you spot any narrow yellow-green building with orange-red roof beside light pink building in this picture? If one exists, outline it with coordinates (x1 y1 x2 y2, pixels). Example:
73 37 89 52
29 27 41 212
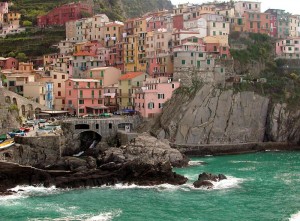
118 72 146 109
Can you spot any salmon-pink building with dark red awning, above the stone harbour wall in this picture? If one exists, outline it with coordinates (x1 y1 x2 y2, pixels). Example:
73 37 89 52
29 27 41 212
65 79 107 116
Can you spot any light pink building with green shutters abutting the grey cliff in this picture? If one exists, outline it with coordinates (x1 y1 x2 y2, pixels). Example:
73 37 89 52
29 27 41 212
135 77 180 118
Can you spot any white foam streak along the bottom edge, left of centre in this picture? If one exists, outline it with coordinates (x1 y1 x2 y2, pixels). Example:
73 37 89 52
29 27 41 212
29 210 122 221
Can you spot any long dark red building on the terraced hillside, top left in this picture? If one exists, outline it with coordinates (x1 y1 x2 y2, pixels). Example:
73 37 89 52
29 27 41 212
37 3 93 27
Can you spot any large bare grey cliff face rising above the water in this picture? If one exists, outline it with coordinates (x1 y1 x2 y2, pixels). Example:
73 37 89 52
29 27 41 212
152 85 300 144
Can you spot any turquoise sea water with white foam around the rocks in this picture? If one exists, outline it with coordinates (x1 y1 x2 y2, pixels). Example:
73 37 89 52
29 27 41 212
0 152 300 221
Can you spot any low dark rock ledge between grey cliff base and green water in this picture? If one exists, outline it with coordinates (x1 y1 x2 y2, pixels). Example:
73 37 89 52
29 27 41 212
170 142 300 157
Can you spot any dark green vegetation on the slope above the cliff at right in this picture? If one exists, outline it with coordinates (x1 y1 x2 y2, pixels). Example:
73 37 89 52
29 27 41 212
230 32 300 108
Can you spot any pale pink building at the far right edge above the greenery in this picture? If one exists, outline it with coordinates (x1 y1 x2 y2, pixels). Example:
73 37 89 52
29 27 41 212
276 37 300 59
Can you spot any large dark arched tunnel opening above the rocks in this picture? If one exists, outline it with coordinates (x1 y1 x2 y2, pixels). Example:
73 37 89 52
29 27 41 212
79 131 102 151
